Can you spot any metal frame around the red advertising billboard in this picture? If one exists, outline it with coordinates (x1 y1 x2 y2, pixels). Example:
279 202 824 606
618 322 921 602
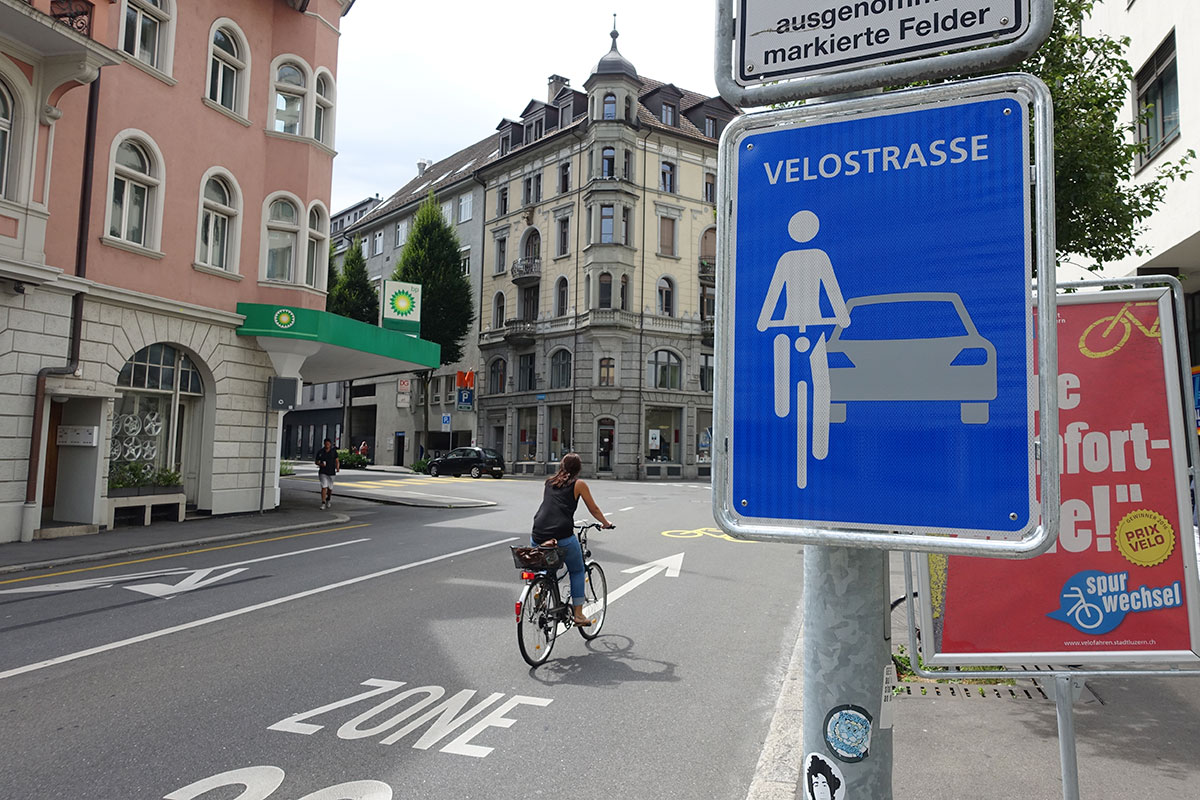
904 276 1200 678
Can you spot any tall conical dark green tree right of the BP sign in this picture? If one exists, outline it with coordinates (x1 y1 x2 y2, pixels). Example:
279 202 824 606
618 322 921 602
392 192 475 453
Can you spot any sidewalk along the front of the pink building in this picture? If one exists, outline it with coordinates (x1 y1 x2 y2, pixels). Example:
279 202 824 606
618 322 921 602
0 488 349 575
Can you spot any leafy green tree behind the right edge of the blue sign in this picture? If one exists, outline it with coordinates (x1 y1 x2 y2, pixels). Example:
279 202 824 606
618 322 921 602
1020 0 1195 269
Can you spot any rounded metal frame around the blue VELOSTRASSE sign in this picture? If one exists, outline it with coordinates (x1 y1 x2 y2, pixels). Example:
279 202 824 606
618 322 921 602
713 74 1060 558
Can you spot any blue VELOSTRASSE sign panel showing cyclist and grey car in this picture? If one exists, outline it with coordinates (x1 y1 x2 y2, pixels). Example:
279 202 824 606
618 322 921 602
720 94 1037 536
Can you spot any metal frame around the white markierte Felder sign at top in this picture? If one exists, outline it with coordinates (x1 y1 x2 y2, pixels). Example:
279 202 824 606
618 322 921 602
713 0 1054 108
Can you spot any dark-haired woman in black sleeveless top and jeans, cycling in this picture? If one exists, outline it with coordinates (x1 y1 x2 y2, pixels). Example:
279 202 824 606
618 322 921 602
532 453 616 627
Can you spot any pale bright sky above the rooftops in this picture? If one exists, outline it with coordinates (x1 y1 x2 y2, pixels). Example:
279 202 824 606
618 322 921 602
331 0 716 213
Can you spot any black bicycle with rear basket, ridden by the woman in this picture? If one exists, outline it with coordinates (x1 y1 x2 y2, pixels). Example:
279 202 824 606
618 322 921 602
512 522 608 667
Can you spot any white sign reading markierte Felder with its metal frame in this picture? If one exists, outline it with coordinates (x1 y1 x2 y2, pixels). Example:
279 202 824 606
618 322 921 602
715 0 1054 108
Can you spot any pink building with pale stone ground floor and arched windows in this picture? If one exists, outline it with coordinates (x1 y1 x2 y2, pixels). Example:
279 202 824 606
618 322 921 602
0 0 428 542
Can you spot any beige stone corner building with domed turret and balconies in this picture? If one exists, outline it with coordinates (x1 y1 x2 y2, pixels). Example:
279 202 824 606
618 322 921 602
476 31 737 480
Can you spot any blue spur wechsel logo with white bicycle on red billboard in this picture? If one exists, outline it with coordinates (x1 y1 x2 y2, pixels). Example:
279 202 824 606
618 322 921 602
1046 570 1183 636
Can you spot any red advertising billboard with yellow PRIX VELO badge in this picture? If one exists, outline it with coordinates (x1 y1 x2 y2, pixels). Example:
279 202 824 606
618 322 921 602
922 289 1200 664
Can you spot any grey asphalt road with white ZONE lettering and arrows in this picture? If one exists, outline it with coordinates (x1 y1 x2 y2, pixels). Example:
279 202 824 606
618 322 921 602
0 473 802 800
